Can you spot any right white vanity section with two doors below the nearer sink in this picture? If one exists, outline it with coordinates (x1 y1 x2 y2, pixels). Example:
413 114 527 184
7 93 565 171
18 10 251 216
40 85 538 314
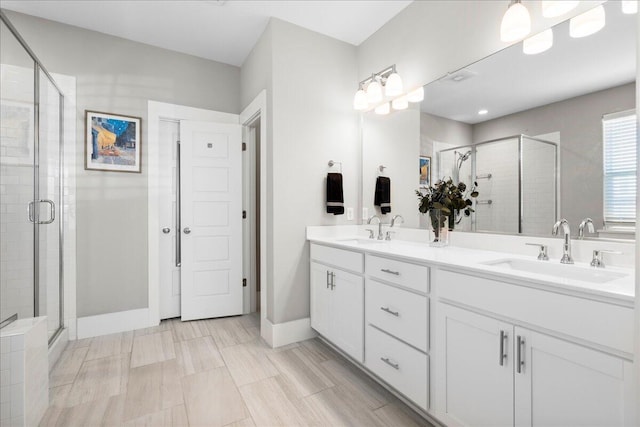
435 271 633 426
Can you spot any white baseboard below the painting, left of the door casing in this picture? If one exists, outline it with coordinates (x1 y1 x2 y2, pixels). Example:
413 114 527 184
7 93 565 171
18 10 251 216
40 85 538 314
77 308 150 339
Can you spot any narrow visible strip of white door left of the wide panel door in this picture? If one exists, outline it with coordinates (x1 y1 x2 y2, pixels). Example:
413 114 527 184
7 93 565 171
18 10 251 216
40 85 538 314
156 120 180 319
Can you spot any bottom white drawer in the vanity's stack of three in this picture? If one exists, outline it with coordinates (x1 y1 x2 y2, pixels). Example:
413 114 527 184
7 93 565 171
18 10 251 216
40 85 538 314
365 325 429 409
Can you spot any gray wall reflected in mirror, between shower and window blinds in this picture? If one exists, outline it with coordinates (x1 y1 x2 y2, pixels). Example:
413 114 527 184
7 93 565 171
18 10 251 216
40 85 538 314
473 83 635 237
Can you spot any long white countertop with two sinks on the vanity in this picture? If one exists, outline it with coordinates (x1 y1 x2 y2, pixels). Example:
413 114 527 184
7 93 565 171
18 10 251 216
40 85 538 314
308 235 635 307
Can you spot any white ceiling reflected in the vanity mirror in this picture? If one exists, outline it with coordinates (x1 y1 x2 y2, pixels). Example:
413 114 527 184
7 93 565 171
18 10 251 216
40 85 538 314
421 1 637 124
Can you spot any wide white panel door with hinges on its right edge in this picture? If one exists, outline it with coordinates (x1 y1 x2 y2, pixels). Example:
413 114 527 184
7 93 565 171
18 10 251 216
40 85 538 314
180 121 243 321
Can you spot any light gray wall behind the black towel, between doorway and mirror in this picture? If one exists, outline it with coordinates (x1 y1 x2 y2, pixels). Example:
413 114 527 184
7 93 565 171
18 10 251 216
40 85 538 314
242 19 360 324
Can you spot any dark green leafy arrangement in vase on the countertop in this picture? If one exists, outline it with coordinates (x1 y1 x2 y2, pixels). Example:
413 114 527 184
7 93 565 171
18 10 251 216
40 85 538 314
416 178 479 241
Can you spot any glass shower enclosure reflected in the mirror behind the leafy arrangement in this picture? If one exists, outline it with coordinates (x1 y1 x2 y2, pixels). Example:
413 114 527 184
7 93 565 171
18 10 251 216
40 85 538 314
438 135 558 235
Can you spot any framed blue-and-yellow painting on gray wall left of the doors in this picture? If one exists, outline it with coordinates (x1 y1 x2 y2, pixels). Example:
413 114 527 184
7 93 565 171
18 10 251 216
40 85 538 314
84 110 142 173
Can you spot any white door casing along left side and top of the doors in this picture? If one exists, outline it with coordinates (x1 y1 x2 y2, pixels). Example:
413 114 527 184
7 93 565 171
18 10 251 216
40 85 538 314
146 101 240 326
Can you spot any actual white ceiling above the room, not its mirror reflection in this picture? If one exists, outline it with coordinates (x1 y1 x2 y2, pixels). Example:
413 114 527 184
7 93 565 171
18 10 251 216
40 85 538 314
0 0 411 66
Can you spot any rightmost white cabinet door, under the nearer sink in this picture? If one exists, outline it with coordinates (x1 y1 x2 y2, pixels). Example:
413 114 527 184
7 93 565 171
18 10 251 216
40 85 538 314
515 327 633 427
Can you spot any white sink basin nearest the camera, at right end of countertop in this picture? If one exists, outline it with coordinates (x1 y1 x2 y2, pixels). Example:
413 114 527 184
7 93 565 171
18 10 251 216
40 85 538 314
483 258 626 283
